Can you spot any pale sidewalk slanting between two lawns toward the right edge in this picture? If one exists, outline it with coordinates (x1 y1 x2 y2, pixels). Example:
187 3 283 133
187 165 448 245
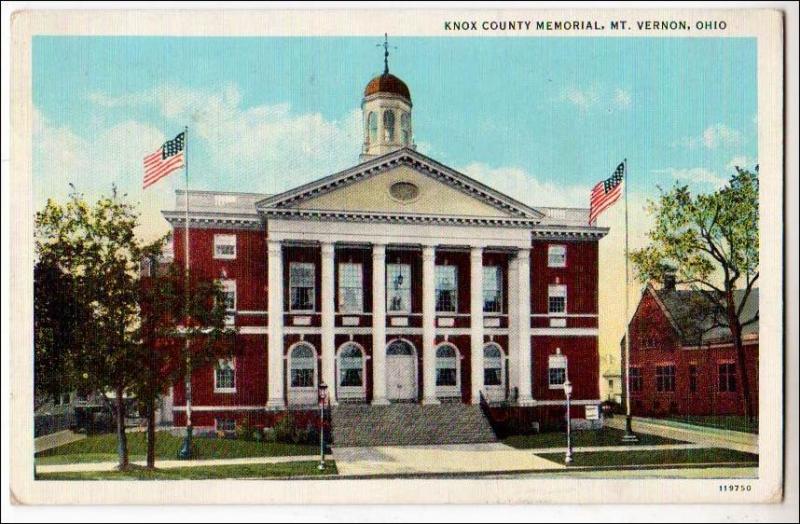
605 417 758 454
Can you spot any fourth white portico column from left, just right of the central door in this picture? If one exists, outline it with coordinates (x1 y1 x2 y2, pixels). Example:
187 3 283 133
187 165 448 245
422 246 439 404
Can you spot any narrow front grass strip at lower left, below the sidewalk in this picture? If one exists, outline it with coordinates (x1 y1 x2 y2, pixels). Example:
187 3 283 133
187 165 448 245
36 461 338 480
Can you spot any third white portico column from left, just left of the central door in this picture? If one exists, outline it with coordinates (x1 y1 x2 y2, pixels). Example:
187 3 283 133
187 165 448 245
372 244 389 406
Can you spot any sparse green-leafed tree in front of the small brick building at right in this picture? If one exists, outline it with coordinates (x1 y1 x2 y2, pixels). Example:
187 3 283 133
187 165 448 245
631 166 759 418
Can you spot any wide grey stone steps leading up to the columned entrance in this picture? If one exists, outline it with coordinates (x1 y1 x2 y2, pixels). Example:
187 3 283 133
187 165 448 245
332 403 497 447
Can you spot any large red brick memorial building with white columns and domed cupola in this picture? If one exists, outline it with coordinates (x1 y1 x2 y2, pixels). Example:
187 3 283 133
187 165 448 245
164 63 607 436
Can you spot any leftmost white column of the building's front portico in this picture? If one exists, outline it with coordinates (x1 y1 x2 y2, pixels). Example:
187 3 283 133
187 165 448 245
267 240 286 409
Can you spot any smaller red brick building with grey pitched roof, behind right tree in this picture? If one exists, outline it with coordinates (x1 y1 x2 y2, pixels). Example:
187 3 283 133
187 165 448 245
622 279 758 417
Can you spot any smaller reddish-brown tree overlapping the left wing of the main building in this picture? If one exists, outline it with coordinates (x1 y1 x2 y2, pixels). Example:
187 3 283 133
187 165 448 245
135 260 234 468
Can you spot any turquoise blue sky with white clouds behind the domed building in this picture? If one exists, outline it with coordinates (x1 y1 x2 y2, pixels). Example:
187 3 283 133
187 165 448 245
33 36 757 376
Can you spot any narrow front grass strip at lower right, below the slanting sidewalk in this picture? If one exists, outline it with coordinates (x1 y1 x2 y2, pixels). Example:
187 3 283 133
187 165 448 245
539 448 758 467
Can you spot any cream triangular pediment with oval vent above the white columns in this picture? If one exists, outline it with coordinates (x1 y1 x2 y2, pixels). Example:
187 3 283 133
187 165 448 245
257 149 543 219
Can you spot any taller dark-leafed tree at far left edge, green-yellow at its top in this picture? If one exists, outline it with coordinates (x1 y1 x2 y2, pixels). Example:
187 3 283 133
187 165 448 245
34 187 165 469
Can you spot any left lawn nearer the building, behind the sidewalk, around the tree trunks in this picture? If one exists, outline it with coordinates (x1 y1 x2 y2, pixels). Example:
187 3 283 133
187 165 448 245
36 431 319 464
